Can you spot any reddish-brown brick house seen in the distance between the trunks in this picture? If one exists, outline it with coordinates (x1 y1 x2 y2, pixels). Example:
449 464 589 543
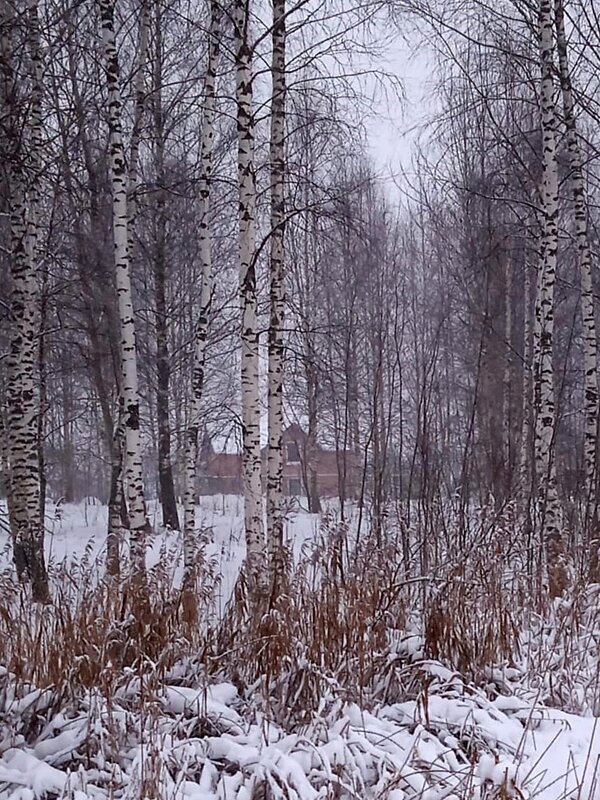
198 424 359 497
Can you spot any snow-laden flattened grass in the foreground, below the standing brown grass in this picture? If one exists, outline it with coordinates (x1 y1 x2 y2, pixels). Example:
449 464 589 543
0 668 600 800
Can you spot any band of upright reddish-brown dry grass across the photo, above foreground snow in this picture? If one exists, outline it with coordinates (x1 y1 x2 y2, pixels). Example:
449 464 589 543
0 512 600 712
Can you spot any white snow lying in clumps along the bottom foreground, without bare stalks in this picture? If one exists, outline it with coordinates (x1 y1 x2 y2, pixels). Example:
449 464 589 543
0 683 600 800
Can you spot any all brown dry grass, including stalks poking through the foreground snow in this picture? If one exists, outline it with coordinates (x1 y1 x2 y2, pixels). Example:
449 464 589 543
0 506 600 800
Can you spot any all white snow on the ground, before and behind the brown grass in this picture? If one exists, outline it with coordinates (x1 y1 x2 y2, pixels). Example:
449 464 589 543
0 498 600 800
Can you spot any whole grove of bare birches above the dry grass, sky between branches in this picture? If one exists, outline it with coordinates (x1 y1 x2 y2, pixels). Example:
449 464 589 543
0 0 600 608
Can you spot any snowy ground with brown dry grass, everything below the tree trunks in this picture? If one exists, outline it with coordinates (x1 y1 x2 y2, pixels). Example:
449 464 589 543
0 504 600 800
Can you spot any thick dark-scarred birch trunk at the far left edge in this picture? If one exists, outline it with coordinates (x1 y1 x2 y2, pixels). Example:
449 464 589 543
1 0 49 602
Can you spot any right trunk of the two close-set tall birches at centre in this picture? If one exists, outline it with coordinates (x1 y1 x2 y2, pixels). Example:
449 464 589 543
267 0 286 597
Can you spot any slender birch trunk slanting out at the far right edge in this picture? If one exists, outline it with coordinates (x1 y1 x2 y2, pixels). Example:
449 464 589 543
554 0 598 523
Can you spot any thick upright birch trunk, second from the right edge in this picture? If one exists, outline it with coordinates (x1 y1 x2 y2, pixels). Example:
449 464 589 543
534 0 569 597
